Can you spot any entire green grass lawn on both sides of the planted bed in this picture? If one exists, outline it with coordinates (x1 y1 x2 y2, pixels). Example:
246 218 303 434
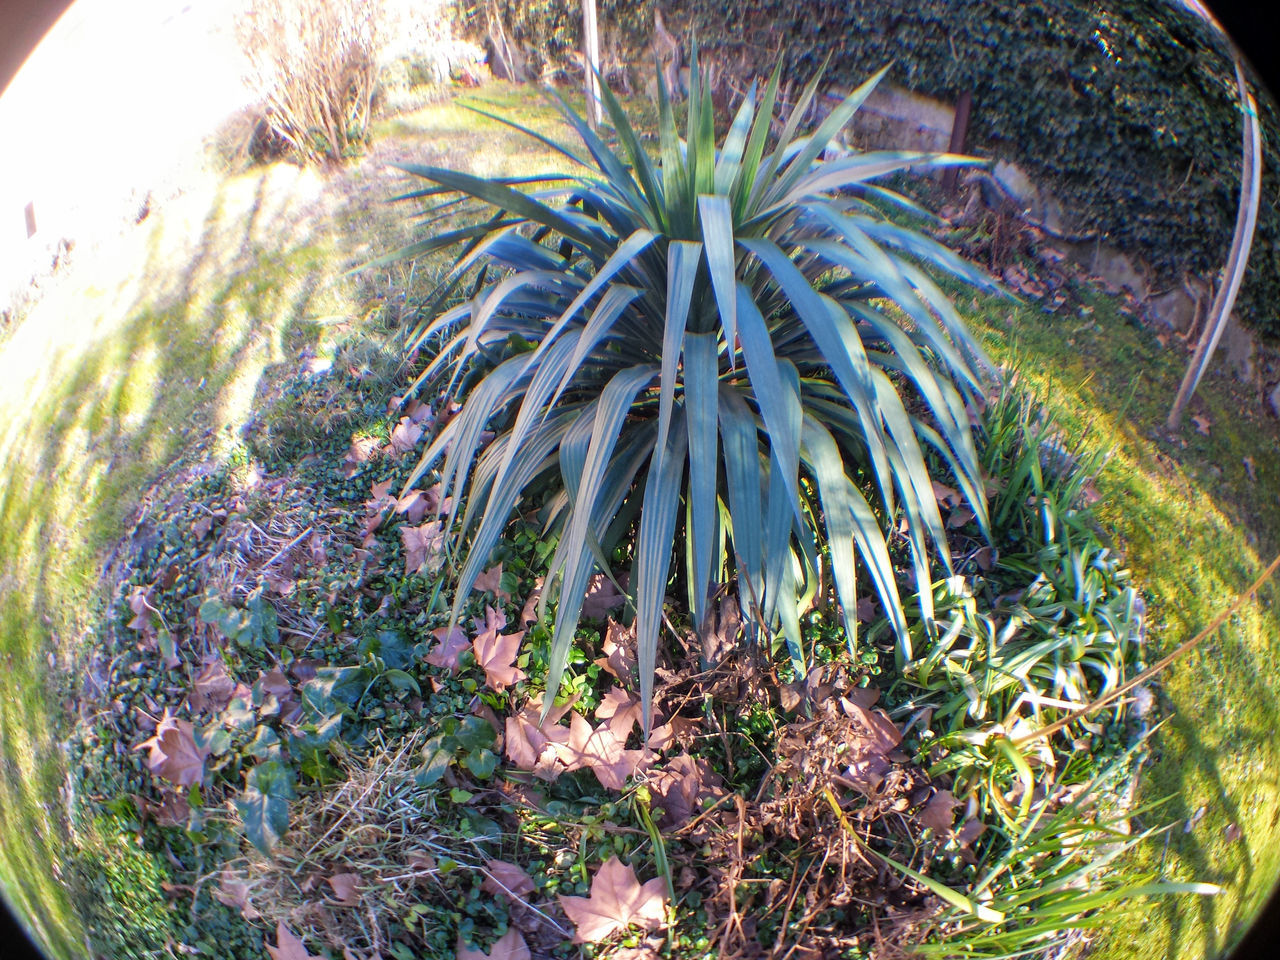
0 84 1280 960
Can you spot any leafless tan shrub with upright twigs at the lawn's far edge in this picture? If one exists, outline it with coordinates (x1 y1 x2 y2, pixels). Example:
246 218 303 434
236 0 381 163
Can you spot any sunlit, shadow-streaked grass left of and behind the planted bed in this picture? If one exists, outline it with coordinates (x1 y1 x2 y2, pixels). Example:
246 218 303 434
0 84 583 957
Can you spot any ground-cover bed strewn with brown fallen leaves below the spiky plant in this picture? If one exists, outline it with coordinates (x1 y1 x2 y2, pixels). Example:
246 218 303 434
72 332 1162 960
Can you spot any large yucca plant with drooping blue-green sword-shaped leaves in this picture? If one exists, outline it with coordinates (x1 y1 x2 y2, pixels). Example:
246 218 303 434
393 50 995 723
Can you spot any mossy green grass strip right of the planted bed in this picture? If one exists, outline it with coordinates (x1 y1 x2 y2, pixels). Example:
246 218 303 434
967 288 1280 960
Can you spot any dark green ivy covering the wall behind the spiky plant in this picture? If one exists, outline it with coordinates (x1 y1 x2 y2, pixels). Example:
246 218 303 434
488 0 1280 338
